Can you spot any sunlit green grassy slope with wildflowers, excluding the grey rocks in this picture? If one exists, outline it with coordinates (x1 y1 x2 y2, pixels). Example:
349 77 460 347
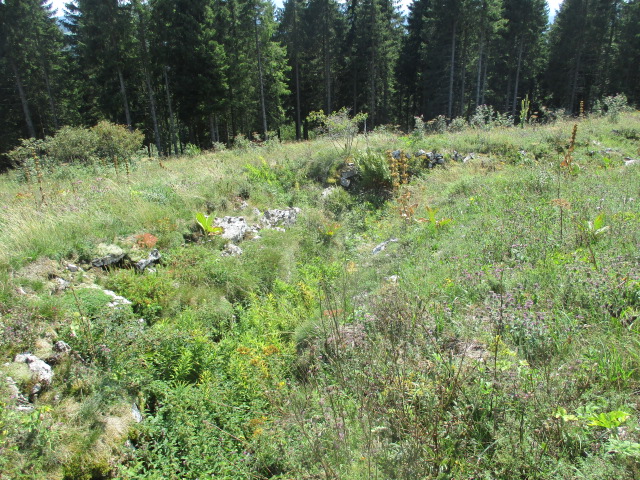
0 113 640 479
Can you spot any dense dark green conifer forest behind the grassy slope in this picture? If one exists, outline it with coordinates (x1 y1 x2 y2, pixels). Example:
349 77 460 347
0 0 640 166
